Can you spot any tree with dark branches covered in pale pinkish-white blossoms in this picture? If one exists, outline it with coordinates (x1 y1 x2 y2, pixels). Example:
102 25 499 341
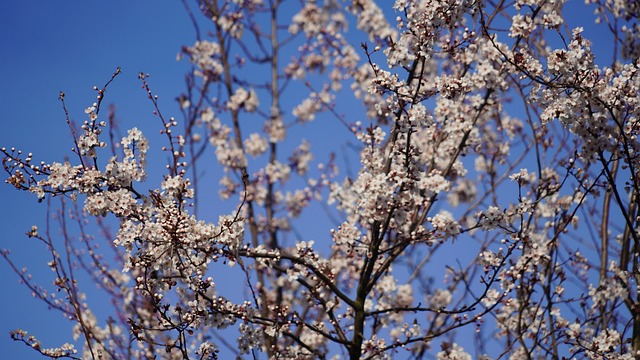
2 0 640 359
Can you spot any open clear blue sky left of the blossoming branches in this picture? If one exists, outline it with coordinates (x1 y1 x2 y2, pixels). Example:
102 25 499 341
0 0 620 359
